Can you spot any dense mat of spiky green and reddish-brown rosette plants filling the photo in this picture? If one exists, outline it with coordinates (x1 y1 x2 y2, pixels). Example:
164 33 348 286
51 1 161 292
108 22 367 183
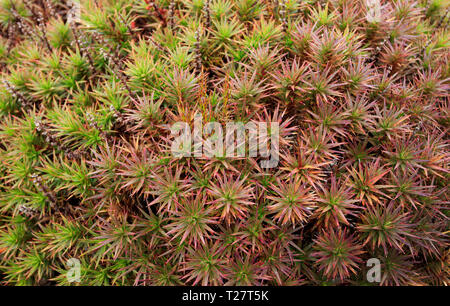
0 0 450 285
